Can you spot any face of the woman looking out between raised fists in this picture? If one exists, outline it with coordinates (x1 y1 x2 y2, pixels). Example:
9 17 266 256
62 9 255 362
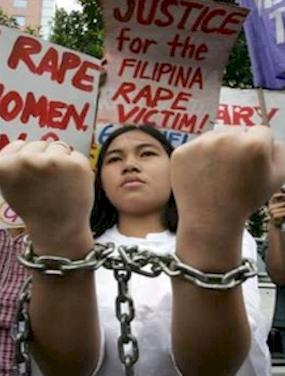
101 130 171 215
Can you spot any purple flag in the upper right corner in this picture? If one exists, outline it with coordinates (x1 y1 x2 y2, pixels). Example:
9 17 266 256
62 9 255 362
237 0 285 89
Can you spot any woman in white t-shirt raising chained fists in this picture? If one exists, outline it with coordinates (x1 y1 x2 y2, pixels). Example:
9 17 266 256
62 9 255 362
0 127 280 376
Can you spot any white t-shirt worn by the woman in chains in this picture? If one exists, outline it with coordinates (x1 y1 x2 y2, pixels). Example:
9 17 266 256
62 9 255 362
32 227 271 376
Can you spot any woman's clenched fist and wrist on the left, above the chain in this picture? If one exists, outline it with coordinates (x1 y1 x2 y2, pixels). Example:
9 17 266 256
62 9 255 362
0 141 93 257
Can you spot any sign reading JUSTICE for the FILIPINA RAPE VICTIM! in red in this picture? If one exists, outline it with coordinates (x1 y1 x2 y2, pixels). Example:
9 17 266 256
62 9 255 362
96 0 247 138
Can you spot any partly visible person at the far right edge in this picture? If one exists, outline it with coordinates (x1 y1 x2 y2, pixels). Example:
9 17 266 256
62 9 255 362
265 188 285 354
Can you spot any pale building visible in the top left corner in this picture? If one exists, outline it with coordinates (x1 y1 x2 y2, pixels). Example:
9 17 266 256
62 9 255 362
0 0 55 39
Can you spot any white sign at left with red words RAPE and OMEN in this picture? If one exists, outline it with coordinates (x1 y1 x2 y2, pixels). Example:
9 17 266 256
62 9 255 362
0 26 101 227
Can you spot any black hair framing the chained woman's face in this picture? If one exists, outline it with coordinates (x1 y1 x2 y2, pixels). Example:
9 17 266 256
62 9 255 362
90 125 178 237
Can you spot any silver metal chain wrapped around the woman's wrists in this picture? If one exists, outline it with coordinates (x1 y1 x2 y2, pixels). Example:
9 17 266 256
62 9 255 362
14 241 257 376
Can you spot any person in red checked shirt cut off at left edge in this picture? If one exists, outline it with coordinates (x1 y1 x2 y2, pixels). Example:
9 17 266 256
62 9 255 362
0 227 28 376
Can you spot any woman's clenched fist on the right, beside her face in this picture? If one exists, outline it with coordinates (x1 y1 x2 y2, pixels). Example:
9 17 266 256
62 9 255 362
171 126 285 231
